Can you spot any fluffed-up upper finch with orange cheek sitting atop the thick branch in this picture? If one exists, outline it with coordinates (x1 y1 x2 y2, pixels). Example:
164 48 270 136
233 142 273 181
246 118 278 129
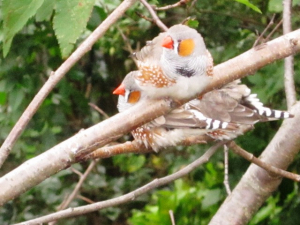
134 24 213 99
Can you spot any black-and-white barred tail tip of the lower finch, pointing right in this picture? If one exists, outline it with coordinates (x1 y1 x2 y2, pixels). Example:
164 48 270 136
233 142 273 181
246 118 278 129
246 94 294 120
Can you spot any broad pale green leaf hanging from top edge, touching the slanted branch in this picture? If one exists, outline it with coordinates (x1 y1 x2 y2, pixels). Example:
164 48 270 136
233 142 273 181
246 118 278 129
53 0 95 57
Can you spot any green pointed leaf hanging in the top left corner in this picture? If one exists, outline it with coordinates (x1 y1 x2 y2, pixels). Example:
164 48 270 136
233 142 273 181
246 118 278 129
3 0 44 57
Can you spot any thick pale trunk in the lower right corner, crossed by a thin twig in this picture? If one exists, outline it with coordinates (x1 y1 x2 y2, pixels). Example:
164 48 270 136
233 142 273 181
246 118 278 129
209 102 300 225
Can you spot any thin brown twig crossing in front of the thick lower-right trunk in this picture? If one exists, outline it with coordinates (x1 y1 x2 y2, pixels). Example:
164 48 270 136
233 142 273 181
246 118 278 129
227 141 300 182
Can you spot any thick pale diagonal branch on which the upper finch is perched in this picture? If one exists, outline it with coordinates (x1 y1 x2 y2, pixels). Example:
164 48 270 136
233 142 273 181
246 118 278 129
0 30 300 205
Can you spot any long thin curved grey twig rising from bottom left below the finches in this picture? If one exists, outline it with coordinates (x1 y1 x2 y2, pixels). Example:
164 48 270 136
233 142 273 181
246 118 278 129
18 142 226 225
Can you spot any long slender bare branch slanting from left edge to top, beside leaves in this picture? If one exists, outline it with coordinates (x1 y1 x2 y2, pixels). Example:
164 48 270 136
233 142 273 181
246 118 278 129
0 0 137 168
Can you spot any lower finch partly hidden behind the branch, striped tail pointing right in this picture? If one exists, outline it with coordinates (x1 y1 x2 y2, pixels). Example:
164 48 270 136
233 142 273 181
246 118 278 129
114 71 293 152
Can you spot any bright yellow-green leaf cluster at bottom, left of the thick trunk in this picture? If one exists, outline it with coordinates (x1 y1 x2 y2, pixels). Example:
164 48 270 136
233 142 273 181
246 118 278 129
129 163 224 225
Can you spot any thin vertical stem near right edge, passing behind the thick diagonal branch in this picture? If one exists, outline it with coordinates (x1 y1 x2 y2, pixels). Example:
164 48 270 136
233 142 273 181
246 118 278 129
283 0 297 109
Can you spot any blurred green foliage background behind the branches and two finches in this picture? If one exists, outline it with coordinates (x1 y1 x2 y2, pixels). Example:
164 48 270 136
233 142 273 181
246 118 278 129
0 0 300 224
